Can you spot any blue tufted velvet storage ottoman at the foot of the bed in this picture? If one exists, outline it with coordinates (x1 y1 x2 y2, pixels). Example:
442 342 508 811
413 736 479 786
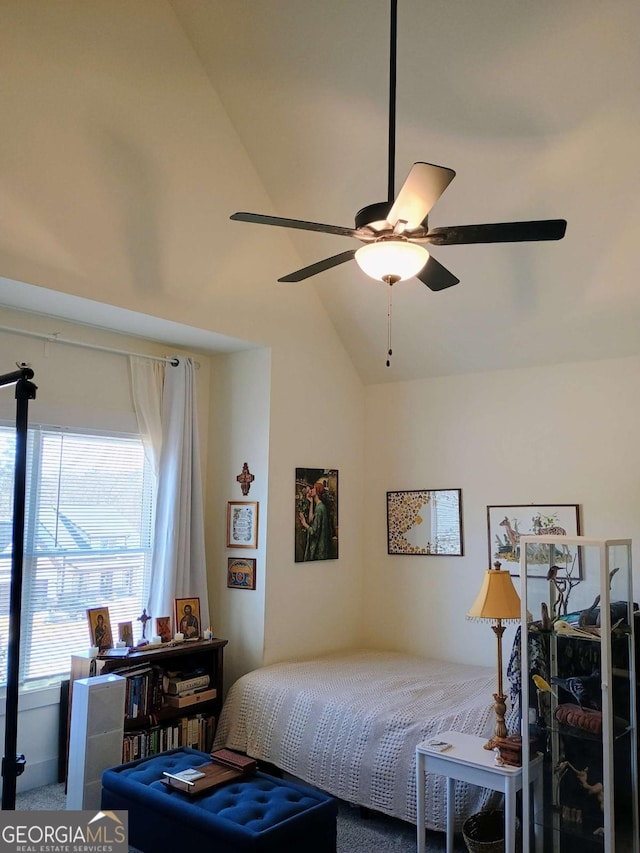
102 748 338 853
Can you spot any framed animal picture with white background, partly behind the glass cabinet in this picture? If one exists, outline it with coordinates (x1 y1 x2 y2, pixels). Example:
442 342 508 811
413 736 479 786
487 504 582 580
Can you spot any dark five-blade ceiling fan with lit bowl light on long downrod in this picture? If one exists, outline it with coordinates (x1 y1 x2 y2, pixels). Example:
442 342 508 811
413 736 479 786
231 0 567 364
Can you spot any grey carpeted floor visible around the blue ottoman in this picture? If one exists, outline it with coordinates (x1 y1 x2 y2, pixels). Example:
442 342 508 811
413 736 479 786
16 784 467 853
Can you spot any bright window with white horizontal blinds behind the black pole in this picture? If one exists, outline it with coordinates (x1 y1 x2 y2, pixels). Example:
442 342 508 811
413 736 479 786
0 425 154 685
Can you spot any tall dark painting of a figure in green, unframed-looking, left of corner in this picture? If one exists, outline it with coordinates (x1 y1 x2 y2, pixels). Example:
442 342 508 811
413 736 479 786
294 468 338 563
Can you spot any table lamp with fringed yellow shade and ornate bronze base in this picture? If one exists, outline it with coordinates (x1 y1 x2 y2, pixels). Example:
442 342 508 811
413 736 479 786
467 561 520 749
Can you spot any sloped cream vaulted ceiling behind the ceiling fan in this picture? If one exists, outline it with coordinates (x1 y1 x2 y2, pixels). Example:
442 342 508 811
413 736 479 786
166 0 640 383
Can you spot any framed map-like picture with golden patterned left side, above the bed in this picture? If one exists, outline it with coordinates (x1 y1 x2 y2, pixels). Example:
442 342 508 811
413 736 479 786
387 489 464 557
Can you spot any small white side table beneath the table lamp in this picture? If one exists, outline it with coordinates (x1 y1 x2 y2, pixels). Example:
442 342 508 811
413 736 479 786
416 732 542 853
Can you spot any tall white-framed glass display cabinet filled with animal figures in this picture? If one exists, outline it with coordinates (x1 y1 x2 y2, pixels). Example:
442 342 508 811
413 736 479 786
520 536 640 853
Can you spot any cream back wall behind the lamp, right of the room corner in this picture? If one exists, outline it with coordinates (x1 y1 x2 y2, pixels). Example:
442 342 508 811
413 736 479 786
364 358 640 664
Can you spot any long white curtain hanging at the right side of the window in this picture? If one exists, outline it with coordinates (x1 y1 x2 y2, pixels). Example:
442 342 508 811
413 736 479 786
130 357 209 631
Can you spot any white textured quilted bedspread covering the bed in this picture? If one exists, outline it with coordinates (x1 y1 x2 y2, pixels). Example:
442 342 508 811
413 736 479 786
215 650 504 831
